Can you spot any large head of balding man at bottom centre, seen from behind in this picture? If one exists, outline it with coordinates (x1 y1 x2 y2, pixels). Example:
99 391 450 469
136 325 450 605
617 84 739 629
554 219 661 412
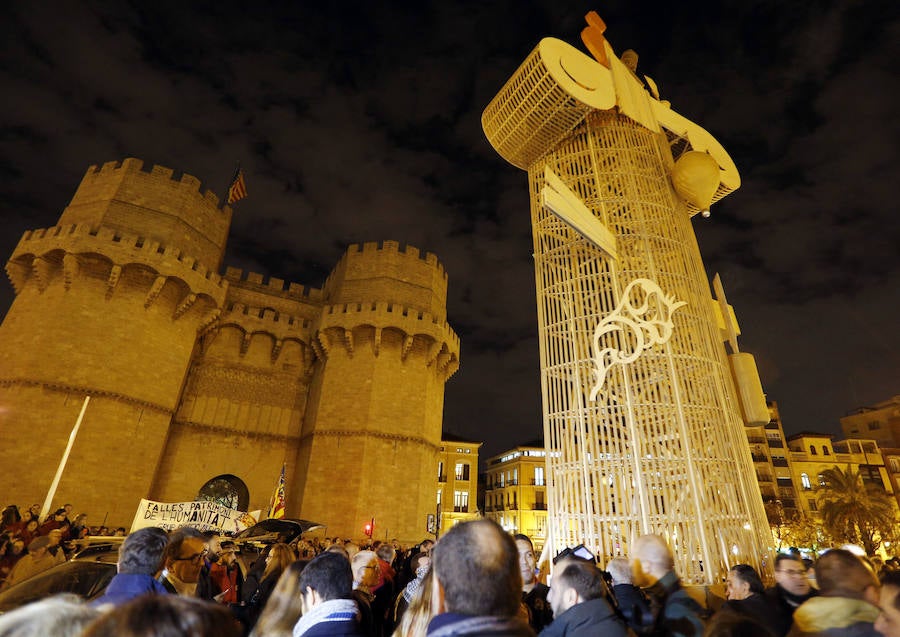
428 520 534 637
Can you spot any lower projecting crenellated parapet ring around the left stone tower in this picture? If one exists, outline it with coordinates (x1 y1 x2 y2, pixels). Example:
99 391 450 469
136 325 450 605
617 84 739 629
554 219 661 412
9 223 225 287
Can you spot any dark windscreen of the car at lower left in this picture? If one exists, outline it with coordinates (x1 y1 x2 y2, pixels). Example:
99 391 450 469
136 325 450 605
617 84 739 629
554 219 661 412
0 562 116 612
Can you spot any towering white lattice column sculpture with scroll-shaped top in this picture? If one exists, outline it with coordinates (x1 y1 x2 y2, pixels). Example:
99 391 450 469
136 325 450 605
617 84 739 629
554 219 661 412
482 14 771 584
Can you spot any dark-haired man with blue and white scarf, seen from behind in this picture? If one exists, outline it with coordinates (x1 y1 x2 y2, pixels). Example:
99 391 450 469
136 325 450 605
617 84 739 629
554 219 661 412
293 551 363 637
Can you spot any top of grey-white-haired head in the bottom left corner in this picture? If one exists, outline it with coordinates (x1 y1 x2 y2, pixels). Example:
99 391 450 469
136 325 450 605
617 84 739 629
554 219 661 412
0 595 100 637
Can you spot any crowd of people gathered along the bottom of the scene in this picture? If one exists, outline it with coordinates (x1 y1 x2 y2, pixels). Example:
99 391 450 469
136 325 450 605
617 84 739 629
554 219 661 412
0 507 900 637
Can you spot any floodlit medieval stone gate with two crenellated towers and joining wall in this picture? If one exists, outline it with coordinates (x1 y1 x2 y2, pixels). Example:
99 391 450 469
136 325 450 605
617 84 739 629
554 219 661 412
0 159 459 541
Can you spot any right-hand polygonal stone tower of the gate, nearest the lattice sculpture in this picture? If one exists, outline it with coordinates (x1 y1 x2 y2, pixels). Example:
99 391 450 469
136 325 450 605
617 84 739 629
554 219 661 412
296 241 459 538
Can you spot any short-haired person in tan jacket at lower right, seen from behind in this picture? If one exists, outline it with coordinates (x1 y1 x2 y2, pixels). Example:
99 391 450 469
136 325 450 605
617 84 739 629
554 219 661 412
788 549 880 637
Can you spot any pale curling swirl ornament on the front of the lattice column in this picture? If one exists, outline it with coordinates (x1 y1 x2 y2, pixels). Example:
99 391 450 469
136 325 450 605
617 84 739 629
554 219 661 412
590 279 687 400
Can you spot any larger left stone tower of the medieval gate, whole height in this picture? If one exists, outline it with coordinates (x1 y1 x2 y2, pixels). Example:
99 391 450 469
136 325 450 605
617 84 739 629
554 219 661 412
0 159 231 523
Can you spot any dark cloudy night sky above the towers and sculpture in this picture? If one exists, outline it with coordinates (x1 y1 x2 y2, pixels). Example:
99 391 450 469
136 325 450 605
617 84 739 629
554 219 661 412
0 0 900 457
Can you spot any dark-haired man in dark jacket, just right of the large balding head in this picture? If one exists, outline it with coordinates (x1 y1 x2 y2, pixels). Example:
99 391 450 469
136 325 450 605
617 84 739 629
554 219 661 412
541 559 628 637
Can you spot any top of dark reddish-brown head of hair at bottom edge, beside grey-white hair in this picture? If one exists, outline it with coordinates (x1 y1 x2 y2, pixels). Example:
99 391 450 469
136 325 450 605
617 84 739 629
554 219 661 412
81 595 241 637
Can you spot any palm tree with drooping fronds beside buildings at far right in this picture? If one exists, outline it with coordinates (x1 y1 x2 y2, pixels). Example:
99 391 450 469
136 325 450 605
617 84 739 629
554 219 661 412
816 465 897 555
